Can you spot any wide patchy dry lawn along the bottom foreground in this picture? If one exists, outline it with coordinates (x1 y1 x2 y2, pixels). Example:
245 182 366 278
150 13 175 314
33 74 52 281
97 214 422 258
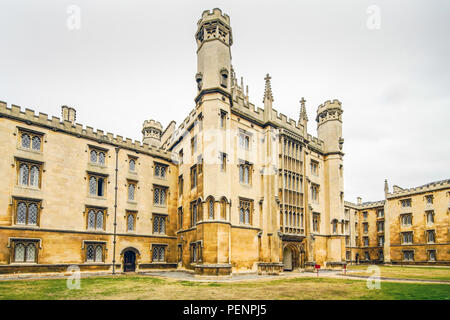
0 275 450 300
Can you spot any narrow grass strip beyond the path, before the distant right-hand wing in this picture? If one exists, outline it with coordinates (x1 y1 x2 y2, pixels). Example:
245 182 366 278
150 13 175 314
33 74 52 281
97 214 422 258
348 265 450 281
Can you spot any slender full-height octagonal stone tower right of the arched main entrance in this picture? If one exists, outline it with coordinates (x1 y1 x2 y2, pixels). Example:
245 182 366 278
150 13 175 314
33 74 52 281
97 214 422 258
316 100 345 262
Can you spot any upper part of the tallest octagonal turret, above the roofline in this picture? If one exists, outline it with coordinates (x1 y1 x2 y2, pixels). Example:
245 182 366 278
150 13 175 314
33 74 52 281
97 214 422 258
195 8 233 101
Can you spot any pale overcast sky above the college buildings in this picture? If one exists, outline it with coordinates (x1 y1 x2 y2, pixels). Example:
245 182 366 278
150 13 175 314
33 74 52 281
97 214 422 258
0 0 450 202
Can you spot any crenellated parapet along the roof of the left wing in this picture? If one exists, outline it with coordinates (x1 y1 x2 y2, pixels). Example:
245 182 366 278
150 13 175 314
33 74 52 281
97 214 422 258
0 101 171 161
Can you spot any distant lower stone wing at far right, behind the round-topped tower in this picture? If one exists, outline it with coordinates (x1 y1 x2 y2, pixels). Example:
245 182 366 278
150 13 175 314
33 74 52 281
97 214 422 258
345 179 450 265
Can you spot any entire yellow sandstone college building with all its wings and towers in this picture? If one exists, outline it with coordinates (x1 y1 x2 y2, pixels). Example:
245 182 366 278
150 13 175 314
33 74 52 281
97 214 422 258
0 9 450 275
